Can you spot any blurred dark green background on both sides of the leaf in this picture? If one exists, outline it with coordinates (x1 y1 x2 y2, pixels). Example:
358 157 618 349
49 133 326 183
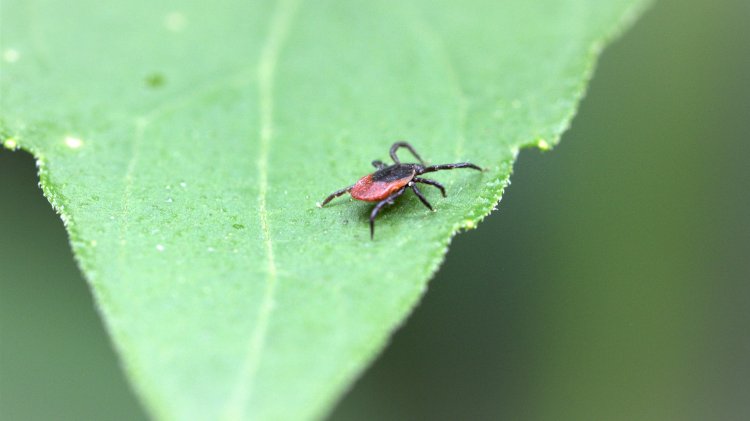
0 0 750 421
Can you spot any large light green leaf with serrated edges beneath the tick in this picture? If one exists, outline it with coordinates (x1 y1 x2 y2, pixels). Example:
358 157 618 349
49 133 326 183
0 0 644 420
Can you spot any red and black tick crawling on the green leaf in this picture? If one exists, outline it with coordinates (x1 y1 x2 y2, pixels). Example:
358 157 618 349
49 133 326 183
319 142 482 238
